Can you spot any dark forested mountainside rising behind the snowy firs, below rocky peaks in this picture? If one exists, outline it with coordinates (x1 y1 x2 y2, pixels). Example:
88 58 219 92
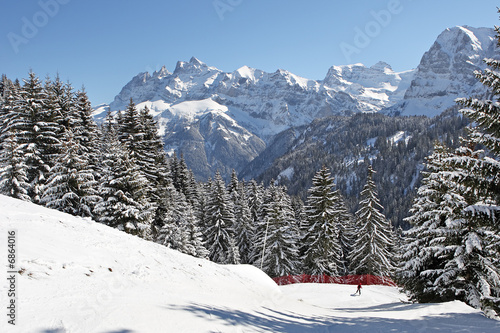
254 108 468 229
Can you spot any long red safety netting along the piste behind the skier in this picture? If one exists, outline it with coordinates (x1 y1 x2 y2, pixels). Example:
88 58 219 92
273 274 396 286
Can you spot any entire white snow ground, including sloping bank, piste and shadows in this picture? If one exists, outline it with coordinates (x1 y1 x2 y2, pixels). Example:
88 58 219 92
0 196 500 333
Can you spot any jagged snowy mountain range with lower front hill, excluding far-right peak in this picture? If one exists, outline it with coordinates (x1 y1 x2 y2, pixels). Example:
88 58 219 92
95 57 413 179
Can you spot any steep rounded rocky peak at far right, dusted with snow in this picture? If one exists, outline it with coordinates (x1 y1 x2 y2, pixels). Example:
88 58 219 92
383 26 498 117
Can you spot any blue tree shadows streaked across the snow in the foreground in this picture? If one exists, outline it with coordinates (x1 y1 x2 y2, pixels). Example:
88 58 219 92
169 303 500 333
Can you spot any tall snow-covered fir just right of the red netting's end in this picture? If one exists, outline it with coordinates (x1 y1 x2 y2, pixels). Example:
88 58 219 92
396 142 463 302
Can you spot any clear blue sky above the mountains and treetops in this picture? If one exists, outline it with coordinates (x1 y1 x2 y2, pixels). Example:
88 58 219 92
0 0 500 105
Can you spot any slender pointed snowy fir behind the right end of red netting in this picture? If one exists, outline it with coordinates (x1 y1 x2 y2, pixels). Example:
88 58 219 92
349 165 394 276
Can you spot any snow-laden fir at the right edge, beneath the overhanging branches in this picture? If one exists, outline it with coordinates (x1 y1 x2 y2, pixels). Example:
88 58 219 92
434 147 500 318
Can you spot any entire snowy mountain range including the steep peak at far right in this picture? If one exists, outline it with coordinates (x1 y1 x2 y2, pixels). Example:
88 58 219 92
95 26 495 179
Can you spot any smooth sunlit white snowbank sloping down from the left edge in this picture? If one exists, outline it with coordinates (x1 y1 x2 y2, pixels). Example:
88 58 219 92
0 196 280 332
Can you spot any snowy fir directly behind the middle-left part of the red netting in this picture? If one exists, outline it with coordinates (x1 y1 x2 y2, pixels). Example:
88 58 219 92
304 166 344 276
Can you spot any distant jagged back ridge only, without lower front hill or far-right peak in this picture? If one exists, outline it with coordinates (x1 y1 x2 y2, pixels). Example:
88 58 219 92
97 57 413 139
